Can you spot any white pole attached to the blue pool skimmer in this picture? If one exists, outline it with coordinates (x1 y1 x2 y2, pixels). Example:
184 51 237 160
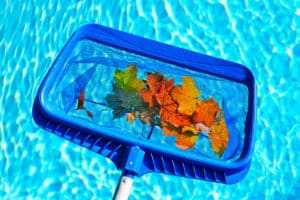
113 175 133 200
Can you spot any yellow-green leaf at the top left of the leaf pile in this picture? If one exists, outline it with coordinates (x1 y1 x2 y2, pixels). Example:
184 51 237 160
114 65 145 93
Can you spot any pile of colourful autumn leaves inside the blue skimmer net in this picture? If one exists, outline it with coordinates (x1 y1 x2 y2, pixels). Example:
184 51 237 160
105 65 229 156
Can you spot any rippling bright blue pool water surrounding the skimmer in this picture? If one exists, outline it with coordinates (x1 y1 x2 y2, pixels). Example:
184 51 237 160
0 0 300 199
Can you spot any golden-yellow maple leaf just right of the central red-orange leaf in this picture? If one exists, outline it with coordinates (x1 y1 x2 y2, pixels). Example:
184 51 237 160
171 76 200 115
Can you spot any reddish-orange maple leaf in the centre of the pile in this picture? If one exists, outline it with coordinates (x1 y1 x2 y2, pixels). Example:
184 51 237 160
155 78 191 127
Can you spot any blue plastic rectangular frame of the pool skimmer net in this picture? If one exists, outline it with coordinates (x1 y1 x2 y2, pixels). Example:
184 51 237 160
33 25 256 183
